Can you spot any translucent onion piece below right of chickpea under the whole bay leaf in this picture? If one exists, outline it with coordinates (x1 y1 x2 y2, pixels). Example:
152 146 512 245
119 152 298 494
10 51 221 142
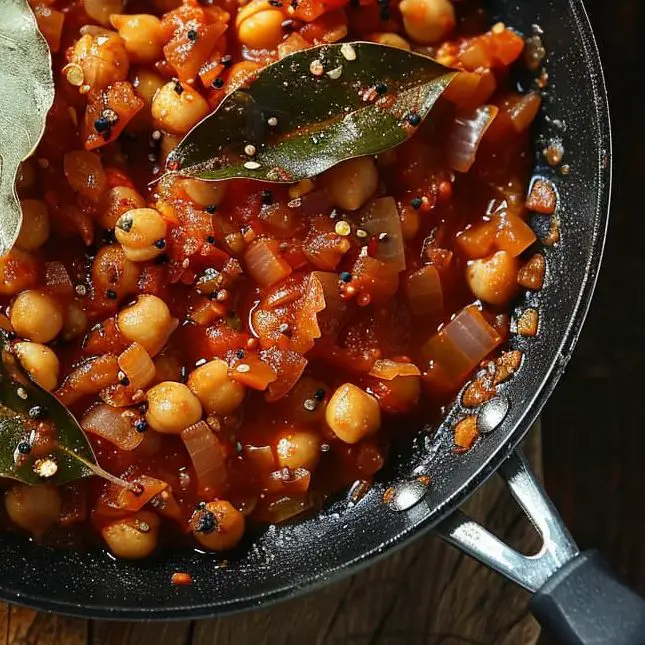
361 197 405 271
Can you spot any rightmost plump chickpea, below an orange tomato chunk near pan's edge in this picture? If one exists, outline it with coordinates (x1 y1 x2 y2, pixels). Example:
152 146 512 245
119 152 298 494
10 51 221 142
466 251 519 305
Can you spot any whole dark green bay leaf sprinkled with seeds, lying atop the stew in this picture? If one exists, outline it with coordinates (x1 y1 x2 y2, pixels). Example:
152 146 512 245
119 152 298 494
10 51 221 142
167 42 456 183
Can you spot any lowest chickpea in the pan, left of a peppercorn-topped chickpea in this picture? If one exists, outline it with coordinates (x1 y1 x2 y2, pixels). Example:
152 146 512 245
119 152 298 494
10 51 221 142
101 511 159 560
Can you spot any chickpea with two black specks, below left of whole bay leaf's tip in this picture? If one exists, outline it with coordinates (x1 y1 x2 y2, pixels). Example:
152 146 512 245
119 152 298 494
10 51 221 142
114 208 168 262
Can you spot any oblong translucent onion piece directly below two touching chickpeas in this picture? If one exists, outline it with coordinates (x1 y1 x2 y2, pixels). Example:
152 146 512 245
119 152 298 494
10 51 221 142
181 421 228 497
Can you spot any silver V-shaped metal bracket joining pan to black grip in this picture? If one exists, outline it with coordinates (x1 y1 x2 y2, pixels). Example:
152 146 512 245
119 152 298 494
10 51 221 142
435 451 580 592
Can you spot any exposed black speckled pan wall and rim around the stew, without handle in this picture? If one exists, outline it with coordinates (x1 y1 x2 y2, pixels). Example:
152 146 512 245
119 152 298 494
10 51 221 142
0 0 611 619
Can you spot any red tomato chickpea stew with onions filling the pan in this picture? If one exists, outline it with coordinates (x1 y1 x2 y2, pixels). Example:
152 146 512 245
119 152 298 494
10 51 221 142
0 0 548 559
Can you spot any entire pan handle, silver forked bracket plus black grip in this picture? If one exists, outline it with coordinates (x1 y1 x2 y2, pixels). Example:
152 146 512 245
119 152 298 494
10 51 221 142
436 452 645 645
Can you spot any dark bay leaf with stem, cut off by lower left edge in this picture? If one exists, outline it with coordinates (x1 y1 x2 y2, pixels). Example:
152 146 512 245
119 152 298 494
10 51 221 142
0 330 132 488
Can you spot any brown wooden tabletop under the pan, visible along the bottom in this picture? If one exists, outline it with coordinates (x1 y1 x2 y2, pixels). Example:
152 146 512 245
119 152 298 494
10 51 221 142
0 433 542 645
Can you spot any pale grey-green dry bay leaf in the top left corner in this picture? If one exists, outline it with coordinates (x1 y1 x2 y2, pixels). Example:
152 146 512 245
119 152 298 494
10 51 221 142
0 0 54 255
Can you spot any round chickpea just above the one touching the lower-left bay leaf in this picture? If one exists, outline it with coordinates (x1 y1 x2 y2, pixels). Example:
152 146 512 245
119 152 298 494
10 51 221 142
9 290 63 343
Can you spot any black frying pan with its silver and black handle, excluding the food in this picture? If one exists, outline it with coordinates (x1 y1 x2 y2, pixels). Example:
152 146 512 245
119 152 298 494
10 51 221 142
0 0 645 645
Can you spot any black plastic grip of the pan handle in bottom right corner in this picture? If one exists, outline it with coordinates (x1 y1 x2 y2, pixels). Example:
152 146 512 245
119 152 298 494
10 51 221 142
531 551 645 645
